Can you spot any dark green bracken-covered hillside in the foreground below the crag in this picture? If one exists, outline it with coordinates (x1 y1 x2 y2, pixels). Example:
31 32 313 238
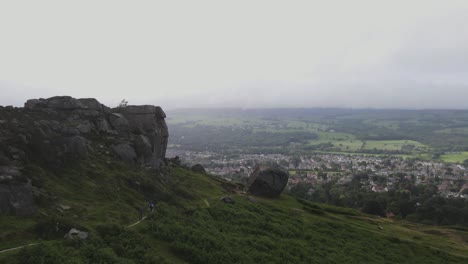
0 157 468 263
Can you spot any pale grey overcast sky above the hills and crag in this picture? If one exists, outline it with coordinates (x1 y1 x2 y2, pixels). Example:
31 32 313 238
0 0 468 109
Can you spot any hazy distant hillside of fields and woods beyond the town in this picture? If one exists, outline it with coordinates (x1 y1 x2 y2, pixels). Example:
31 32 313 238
167 109 468 162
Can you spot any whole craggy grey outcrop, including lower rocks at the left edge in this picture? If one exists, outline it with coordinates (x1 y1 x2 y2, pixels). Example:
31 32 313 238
0 96 168 215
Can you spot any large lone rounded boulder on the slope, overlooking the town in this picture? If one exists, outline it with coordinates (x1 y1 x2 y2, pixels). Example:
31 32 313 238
247 165 289 197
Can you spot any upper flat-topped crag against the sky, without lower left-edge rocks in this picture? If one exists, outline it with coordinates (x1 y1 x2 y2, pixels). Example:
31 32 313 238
0 96 168 168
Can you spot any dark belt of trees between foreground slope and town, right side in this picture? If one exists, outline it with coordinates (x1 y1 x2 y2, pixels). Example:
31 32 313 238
289 173 468 226
